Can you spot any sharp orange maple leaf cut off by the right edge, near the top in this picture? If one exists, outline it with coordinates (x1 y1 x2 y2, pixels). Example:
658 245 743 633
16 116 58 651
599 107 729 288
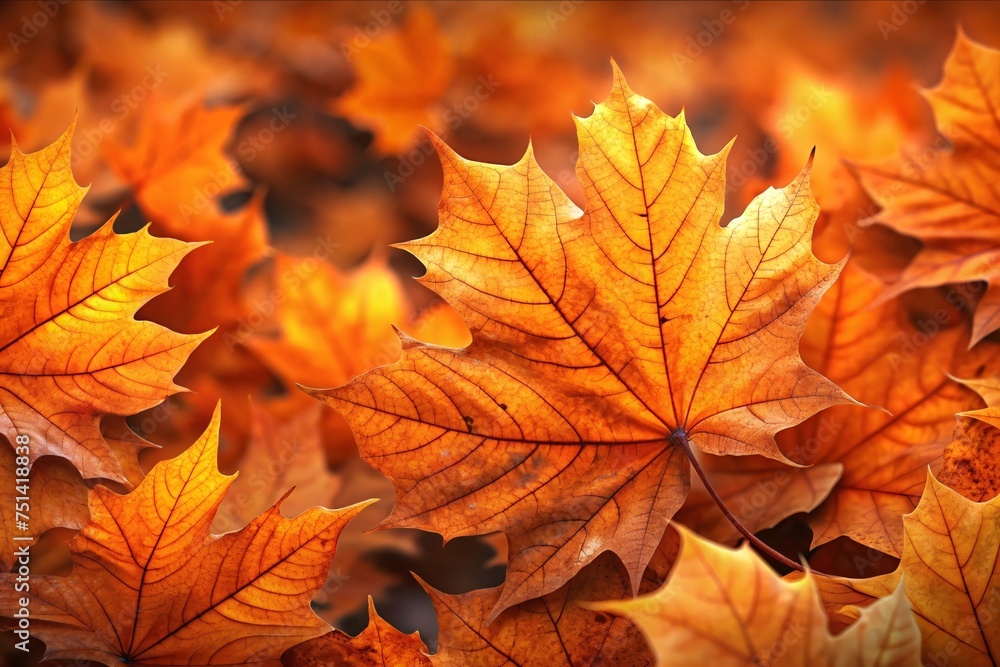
856 31 1000 344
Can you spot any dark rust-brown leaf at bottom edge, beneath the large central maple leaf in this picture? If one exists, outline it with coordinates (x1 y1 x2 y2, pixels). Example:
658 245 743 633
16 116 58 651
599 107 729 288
420 554 655 667
